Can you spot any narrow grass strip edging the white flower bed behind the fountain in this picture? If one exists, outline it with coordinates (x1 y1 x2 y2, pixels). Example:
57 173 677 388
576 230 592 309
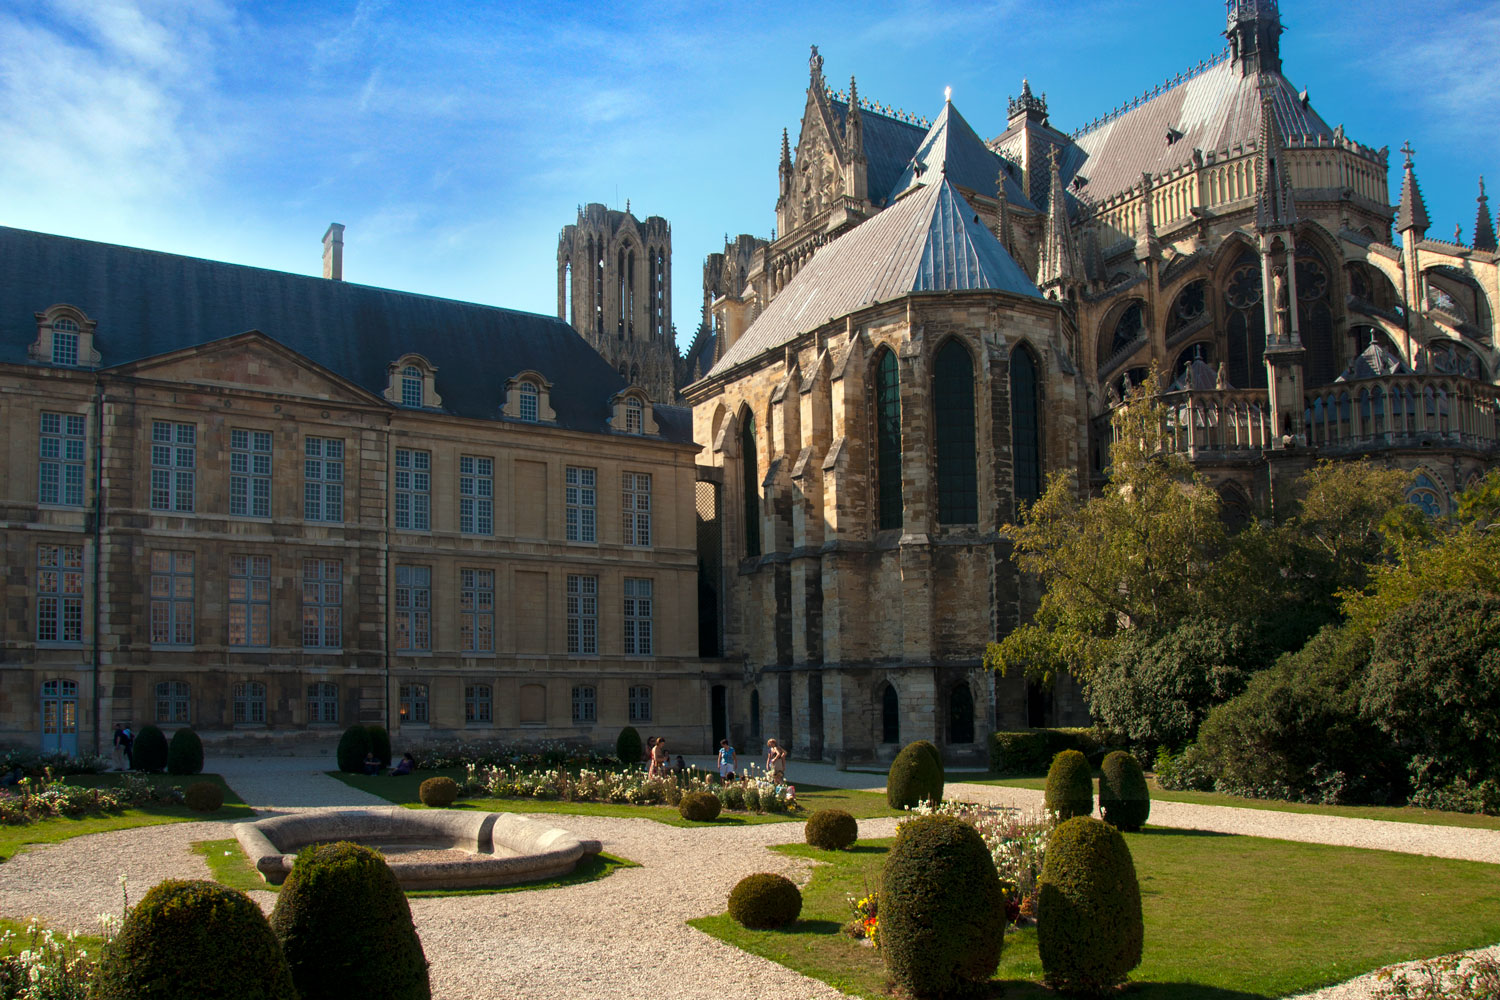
329 768 902 826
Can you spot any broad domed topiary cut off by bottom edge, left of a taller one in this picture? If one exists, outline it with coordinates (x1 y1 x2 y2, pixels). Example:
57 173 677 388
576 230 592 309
90 879 296 1000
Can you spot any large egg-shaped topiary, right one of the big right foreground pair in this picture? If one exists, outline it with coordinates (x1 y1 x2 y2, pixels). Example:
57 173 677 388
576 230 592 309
1038 816 1145 993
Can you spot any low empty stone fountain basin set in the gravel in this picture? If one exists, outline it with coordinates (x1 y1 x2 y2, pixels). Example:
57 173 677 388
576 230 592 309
234 805 603 889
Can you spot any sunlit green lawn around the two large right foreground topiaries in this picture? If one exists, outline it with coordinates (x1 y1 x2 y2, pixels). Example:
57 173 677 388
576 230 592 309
690 828 1500 1000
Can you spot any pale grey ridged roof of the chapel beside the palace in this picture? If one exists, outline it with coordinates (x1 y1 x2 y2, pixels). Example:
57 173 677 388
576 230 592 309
710 178 1043 375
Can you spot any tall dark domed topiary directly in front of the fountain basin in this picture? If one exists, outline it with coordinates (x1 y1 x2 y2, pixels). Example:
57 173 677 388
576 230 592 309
272 841 432 1000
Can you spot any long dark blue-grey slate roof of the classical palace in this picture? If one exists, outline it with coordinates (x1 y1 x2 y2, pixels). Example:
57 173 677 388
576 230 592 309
0 226 692 441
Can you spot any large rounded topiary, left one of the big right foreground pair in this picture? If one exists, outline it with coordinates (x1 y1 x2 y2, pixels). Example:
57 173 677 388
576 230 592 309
881 816 1005 997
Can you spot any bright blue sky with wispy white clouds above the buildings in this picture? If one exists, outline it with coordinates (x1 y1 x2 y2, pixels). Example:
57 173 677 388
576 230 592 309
0 0 1500 352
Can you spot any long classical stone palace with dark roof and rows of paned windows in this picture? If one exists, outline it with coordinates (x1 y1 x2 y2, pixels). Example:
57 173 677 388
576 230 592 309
0 226 726 751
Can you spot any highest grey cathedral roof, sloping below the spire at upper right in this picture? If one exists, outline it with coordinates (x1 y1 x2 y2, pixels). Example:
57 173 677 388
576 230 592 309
1064 58 1334 201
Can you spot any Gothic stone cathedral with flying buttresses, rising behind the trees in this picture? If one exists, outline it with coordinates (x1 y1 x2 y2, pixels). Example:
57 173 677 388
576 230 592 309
684 0 1500 763
